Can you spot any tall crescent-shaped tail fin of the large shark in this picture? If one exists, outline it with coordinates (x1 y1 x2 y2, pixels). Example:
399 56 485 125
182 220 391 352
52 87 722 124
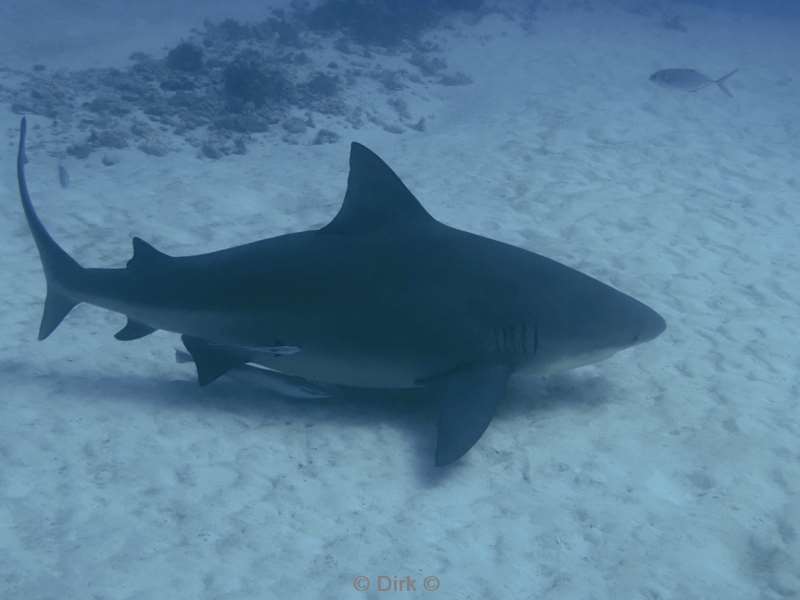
17 117 83 340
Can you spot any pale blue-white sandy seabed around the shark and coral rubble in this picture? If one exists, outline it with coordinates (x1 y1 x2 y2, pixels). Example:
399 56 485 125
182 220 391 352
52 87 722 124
0 2 800 600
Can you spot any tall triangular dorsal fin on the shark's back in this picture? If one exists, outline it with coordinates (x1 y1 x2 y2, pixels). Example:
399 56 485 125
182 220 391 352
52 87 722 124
321 142 433 235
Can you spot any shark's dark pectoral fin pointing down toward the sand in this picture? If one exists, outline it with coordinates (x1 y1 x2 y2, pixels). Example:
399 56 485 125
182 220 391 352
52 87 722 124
433 365 511 466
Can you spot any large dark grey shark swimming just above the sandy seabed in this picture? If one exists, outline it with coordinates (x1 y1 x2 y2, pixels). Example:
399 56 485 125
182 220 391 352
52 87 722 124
17 118 666 465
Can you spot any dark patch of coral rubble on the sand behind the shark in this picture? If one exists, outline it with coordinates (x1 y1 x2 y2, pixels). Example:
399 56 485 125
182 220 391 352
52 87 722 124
0 0 484 158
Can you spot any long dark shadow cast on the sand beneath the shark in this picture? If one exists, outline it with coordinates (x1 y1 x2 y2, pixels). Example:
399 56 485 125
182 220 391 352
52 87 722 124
0 361 613 486
